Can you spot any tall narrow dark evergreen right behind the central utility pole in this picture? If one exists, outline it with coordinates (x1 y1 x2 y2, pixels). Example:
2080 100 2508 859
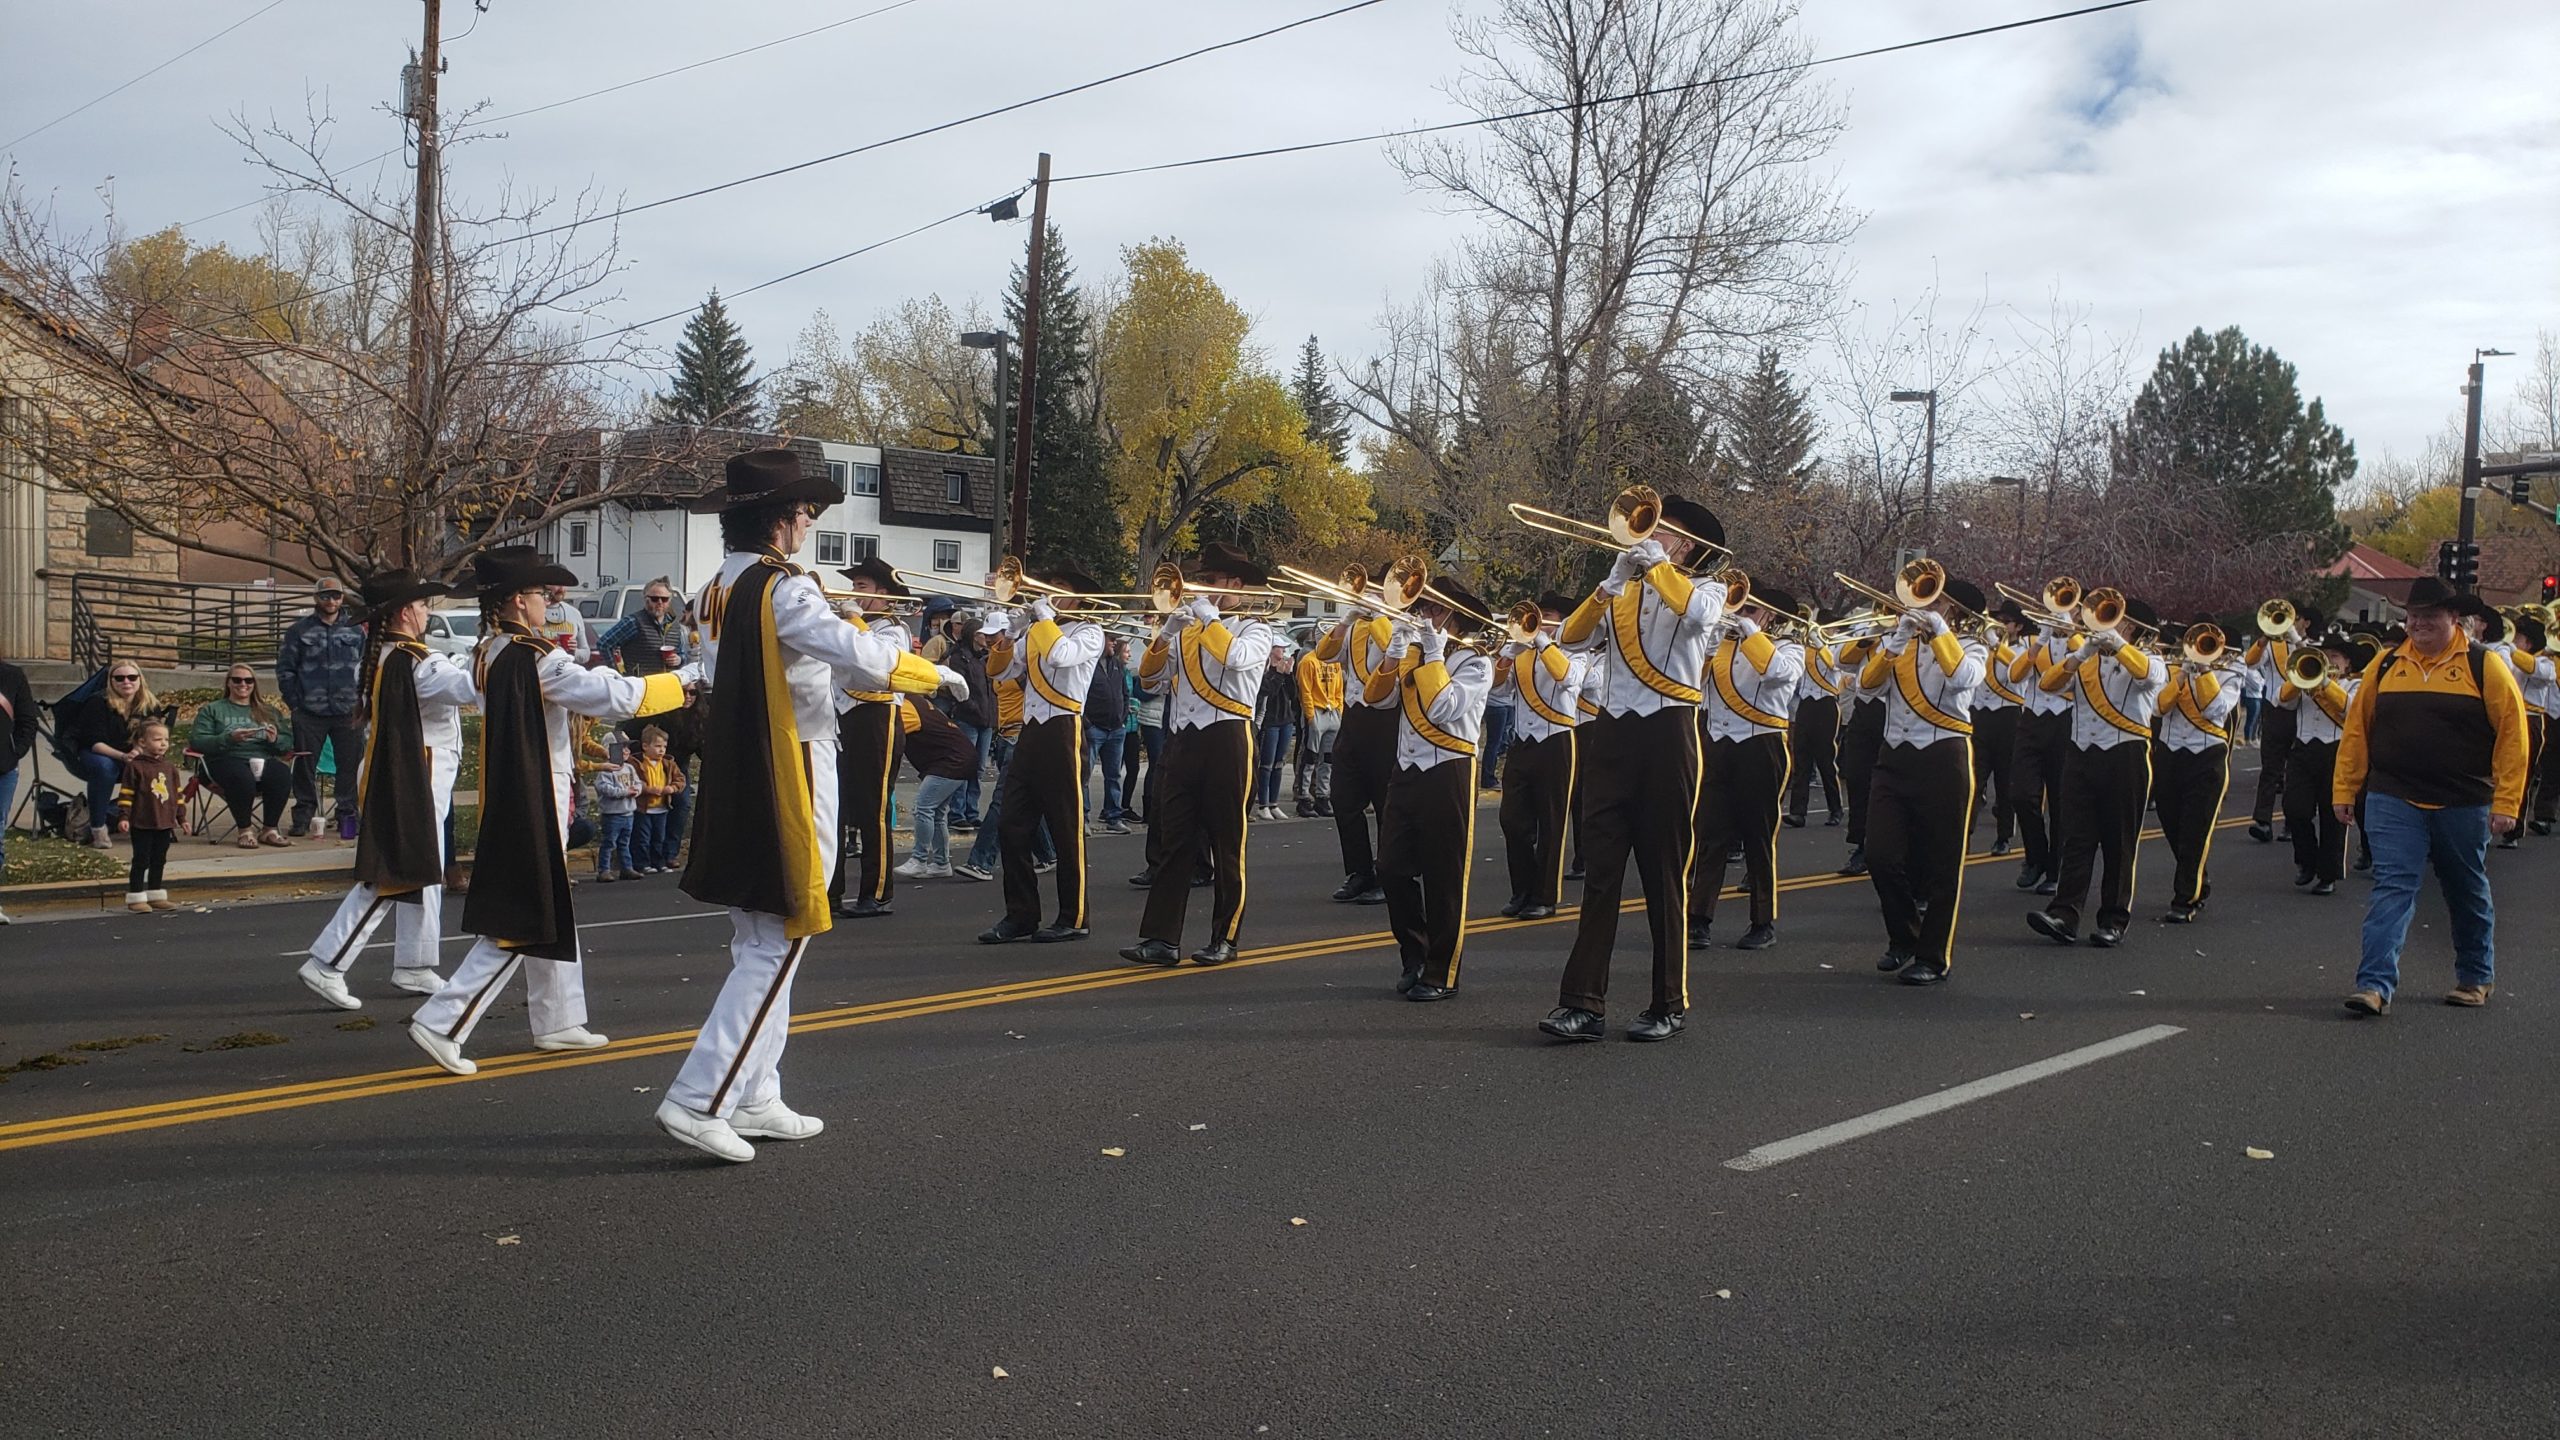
988 225 1129 584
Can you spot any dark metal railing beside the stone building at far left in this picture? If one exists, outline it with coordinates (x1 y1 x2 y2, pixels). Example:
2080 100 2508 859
56 571 312 666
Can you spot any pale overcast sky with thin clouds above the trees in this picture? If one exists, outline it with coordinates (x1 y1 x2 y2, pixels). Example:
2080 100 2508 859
0 0 2560 471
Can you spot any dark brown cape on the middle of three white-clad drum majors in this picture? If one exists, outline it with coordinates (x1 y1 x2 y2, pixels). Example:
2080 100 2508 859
463 625 579 961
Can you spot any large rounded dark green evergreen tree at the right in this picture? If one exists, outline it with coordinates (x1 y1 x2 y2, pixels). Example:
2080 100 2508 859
2115 325 2355 566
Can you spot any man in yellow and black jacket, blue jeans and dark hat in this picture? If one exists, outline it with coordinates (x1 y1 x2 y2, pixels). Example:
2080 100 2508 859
2330 574 2532 1015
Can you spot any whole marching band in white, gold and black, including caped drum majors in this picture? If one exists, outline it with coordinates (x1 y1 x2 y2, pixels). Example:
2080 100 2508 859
254 440 2560 1161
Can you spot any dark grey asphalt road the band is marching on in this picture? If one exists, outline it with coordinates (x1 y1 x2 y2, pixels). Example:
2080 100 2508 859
0 753 2560 1437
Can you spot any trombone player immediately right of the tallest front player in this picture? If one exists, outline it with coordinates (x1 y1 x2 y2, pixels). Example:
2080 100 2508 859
1690 571 1805 951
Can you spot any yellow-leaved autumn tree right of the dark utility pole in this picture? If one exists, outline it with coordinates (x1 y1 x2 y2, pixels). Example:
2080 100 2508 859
1096 241 1370 577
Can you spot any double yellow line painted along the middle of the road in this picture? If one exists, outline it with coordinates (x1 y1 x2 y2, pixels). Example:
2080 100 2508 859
0 817 2248 1150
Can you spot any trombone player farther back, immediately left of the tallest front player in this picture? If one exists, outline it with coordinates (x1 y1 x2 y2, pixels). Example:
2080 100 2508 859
1492 592 1590 920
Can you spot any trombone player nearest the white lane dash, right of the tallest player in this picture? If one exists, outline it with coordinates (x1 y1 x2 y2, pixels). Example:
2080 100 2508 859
1859 576 1989 984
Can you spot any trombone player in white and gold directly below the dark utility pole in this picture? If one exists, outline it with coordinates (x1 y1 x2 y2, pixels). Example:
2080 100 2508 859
978 569 1103 945
